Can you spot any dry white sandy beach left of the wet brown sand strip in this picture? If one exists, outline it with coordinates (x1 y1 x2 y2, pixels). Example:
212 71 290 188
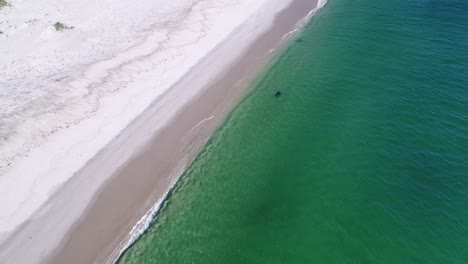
0 0 326 263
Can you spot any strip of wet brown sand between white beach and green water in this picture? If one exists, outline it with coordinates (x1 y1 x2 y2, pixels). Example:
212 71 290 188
46 0 317 264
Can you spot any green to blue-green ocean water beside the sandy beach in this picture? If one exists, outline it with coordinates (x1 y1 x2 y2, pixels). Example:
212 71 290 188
119 0 468 264
